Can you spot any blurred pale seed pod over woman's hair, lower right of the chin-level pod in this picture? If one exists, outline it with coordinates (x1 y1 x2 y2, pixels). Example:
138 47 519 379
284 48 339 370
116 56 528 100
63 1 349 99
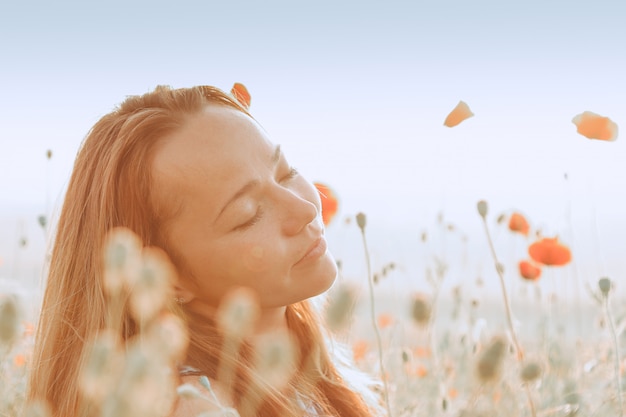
255 330 297 389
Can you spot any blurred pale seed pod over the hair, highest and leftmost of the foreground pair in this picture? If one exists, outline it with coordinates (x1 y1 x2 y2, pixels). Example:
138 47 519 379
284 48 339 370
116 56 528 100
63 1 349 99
104 227 143 296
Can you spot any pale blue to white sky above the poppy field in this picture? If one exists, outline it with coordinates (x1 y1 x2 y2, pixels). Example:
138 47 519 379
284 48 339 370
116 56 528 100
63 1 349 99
0 0 626 300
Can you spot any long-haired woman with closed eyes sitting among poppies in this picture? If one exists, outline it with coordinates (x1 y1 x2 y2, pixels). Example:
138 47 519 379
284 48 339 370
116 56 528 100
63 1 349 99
29 86 378 417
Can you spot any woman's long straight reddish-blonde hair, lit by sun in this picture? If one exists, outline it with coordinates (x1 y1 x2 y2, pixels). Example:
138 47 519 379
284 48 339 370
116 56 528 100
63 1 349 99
27 86 380 417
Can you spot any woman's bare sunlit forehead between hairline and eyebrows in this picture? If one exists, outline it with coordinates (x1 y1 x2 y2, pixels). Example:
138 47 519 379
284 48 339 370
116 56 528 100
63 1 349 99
152 104 273 213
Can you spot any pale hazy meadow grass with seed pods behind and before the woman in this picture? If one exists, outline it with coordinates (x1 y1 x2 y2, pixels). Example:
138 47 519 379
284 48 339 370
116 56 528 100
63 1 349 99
0 206 626 417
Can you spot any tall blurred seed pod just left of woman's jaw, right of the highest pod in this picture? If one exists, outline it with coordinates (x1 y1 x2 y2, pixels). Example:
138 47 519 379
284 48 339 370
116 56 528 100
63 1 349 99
130 247 175 320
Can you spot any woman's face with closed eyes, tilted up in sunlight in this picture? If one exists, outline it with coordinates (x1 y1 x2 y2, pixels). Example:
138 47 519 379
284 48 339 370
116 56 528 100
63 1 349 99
153 105 337 308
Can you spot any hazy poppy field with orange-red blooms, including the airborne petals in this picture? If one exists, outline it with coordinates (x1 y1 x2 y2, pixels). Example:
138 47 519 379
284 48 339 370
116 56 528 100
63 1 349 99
0 83 626 417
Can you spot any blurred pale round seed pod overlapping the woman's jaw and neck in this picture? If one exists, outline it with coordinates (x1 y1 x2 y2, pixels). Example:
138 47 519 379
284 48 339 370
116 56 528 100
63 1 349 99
217 287 260 338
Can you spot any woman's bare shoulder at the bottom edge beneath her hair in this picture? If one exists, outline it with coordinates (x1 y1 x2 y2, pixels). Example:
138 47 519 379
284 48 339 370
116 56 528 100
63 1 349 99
170 375 238 417
